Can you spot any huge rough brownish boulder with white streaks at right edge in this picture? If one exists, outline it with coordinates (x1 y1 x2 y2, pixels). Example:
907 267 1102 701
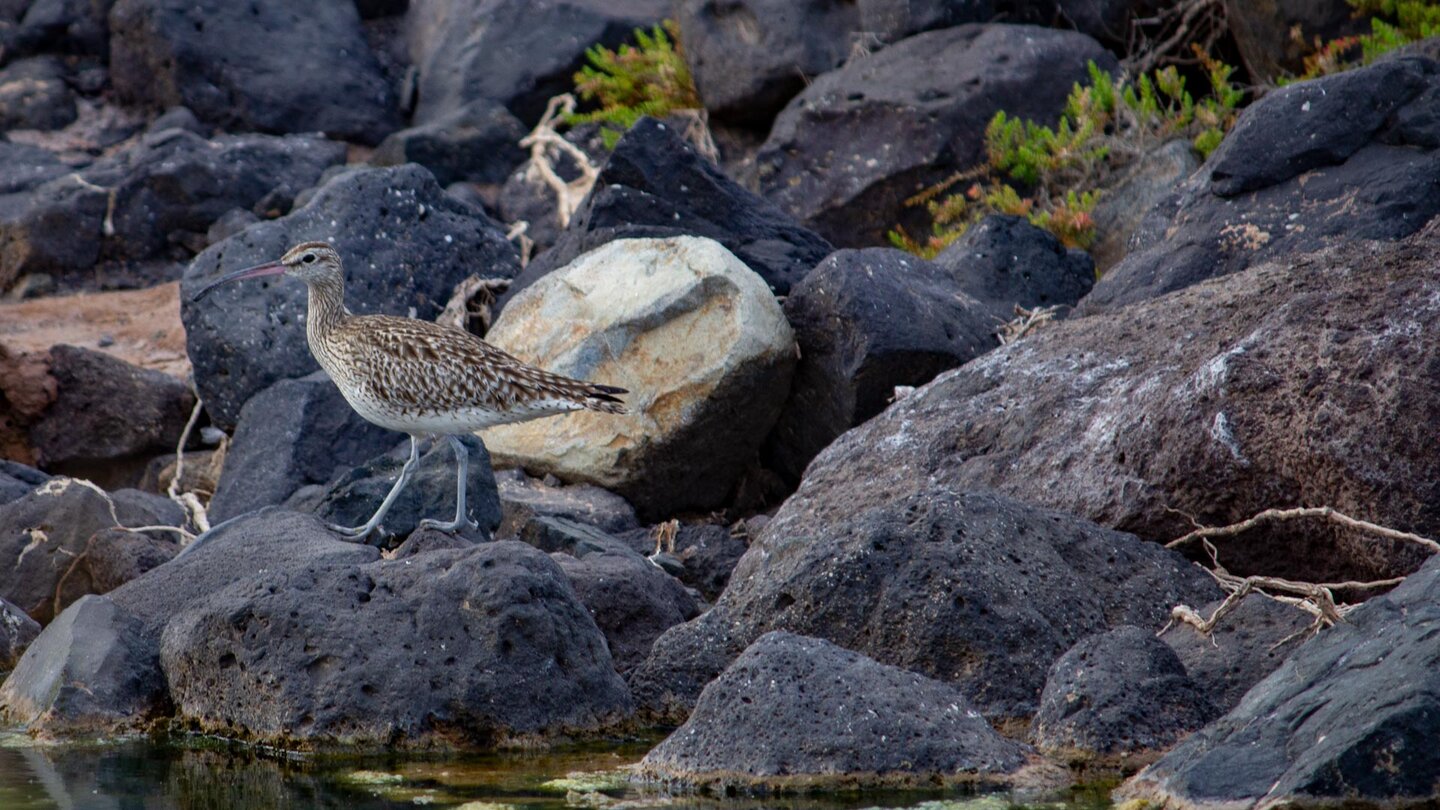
771 229 1440 582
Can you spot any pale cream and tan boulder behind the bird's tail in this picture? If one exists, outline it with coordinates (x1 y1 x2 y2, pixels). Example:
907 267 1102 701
482 236 795 516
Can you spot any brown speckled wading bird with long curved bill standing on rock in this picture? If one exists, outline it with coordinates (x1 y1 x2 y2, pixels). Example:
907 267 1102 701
192 242 629 540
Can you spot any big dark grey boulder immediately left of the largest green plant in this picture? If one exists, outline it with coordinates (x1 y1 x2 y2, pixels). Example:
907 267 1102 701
756 25 1116 248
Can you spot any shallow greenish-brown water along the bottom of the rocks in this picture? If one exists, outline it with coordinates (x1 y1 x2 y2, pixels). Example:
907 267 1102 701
0 735 1109 810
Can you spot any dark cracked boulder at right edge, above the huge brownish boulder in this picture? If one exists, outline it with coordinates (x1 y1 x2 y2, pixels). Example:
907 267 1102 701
1081 58 1440 313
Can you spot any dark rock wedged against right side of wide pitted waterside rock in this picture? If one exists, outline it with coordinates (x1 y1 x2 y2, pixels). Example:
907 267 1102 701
550 536 700 675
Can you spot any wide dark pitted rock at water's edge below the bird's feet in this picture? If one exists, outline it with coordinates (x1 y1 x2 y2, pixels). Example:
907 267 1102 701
161 533 632 748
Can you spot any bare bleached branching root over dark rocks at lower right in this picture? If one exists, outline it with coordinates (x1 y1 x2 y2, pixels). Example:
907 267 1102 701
1161 506 1440 650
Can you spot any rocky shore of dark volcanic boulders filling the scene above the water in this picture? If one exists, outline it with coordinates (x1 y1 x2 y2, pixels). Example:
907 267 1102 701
0 0 1440 807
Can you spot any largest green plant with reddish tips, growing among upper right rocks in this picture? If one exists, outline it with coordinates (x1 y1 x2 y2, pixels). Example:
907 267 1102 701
890 50 1244 258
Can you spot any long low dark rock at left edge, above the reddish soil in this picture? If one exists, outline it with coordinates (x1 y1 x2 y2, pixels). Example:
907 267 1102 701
0 128 346 284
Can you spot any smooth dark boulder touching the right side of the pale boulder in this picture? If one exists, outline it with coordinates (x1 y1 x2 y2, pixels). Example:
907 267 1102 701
766 248 999 481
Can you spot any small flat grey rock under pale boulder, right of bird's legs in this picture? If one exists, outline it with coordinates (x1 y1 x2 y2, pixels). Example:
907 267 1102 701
495 468 639 538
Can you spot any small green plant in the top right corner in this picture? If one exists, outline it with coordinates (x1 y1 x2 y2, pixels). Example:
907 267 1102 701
1280 0 1440 84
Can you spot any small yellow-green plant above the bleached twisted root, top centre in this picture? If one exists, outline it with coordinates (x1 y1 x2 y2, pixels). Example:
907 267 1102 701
566 20 701 148
